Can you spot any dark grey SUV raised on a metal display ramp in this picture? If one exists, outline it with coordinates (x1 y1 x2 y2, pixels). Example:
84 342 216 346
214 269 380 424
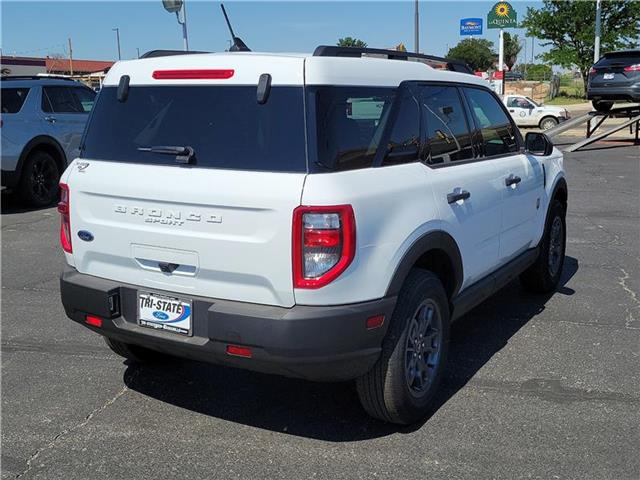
587 50 640 112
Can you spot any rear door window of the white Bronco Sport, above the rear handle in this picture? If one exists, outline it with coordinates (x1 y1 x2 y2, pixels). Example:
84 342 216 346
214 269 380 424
420 86 473 165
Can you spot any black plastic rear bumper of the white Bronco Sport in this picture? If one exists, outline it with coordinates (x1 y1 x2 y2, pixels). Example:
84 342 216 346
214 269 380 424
60 267 396 381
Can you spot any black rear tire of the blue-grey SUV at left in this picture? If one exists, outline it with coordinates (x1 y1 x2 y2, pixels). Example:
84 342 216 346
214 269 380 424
18 150 60 207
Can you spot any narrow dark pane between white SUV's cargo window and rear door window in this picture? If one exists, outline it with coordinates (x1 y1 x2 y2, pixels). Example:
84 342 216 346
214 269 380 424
382 90 420 165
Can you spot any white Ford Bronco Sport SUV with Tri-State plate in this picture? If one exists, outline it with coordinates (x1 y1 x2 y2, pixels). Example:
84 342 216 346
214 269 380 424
58 47 567 424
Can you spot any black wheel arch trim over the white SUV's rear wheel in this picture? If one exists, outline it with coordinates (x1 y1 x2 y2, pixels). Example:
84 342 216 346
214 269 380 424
385 230 463 298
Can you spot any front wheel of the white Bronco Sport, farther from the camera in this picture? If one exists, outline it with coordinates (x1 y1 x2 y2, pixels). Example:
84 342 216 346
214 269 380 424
520 200 567 293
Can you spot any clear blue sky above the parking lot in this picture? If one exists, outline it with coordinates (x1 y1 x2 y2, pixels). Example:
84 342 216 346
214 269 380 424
1 0 542 60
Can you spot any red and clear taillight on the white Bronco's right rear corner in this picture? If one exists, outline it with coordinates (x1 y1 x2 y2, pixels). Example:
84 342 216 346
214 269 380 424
292 205 356 288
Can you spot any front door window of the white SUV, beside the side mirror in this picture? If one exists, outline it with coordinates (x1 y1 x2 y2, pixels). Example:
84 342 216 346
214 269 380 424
464 88 518 157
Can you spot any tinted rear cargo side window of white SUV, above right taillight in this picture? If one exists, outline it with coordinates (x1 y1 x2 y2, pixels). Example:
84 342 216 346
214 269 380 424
309 87 395 170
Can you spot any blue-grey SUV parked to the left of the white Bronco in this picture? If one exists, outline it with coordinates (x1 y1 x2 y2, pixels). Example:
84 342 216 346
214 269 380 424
0 76 96 207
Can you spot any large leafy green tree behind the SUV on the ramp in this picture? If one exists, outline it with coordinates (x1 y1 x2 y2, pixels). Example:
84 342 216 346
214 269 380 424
522 0 640 94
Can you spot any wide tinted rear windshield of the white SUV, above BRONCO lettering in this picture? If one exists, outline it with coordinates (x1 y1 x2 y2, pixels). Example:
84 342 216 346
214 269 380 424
81 86 307 172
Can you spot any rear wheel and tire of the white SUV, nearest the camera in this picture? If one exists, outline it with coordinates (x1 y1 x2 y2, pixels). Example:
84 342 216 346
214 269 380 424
356 269 449 425
